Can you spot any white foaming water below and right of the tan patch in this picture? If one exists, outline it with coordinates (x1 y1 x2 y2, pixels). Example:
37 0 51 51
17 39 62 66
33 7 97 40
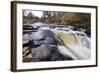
57 31 91 60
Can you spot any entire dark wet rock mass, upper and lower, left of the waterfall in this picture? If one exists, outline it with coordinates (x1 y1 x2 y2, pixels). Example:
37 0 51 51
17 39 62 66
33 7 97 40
24 30 73 62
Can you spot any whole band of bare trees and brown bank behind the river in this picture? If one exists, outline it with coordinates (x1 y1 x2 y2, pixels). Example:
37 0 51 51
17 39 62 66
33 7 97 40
23 10 91 32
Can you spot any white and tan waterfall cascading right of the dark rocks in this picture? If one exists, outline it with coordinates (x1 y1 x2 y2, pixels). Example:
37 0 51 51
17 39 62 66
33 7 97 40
23 24 91 60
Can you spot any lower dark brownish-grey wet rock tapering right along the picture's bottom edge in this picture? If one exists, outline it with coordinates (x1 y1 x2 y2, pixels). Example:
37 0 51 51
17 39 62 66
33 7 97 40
31 44 73 62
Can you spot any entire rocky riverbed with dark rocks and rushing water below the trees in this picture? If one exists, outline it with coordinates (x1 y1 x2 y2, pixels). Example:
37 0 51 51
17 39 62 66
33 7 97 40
23 25 91 62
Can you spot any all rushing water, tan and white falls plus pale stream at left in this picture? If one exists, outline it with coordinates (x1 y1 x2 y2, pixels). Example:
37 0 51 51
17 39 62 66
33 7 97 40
23 24 91 60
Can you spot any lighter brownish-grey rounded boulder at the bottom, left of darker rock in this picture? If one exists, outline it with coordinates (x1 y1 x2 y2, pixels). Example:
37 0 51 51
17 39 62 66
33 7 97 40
31 44 50 61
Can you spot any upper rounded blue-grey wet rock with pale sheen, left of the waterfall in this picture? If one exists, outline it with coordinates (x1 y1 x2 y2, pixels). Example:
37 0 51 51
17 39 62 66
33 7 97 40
31 30 57 45
